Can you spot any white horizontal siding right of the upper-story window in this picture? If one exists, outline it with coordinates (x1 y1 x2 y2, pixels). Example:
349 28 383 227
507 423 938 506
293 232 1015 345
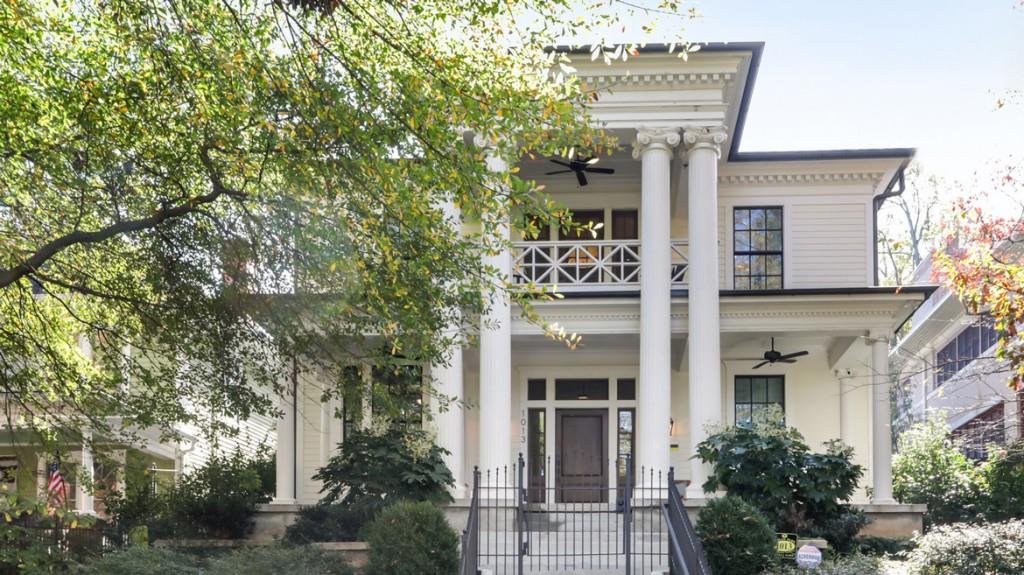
784 203 871 288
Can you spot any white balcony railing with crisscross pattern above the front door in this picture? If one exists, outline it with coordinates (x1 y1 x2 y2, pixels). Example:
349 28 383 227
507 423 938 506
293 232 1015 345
512 239 689 292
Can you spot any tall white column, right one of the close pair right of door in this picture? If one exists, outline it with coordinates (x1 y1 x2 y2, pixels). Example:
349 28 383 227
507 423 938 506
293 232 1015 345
683 126 727 498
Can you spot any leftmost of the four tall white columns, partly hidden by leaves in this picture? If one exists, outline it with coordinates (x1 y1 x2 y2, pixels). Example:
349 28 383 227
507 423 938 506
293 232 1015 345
430 202 466 499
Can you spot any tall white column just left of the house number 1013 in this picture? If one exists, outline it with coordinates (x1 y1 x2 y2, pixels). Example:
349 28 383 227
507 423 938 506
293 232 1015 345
474 137 512 471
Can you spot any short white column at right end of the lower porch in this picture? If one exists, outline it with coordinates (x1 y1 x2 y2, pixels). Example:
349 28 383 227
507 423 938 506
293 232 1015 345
870 331 896 503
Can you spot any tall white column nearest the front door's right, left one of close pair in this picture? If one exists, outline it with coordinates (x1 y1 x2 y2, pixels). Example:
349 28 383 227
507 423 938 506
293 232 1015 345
633 128 680 478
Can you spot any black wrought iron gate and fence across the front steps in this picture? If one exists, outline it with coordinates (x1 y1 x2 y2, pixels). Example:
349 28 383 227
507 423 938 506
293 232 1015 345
463 456 669 575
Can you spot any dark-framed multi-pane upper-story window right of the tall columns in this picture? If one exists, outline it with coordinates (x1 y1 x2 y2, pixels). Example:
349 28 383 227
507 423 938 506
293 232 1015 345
732 207 782 290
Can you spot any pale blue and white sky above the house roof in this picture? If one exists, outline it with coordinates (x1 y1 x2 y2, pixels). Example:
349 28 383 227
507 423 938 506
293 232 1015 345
598 0 1024 190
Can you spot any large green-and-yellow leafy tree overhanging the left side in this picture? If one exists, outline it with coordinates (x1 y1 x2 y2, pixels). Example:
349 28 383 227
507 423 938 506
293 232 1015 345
0 0 690 448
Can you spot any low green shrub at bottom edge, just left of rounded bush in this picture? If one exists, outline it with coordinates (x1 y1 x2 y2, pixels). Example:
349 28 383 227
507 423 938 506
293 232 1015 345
206 545 353 575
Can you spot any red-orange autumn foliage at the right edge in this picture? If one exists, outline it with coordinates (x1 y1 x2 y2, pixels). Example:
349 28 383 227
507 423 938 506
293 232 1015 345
933 164 1024 391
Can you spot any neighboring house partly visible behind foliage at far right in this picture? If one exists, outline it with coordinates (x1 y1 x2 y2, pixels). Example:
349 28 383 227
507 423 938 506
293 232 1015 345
892 250 1024 459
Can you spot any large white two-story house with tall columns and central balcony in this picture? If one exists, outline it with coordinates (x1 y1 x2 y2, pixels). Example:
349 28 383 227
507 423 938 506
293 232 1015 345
265 43 934 530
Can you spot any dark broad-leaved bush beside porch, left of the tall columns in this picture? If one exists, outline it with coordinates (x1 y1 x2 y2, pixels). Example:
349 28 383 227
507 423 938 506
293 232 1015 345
313 429 455 503
